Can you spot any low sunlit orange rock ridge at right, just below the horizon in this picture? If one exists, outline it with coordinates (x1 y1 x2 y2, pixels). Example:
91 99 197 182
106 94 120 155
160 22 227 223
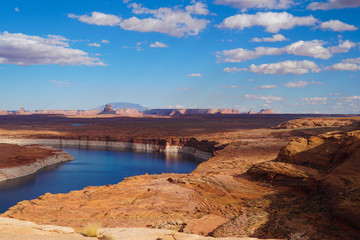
274 118 360 129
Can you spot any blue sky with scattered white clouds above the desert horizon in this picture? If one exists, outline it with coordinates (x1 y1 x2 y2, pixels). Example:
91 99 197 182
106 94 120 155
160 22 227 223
0 0 360 114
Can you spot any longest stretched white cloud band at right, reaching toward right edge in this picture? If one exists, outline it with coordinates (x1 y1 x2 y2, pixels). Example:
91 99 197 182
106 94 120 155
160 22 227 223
217 40 356 62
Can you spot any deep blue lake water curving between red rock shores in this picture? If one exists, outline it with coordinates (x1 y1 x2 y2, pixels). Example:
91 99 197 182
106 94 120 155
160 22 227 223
0 148 199 213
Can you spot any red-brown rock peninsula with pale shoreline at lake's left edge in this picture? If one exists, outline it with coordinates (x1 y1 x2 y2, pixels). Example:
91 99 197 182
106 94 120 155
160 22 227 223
0 144 74 182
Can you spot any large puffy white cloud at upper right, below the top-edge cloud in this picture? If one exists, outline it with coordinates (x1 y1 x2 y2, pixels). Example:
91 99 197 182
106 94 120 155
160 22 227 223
219 12 318 33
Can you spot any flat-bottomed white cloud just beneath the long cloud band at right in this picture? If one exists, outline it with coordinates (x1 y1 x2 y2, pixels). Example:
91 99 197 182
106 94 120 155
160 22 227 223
248 60 320 75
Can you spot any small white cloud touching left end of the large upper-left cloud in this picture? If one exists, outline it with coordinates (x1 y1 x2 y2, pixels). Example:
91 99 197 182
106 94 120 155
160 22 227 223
68 12 121 26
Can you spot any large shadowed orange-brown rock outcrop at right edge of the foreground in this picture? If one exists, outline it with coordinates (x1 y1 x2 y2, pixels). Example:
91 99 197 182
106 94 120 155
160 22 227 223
248 130 360 229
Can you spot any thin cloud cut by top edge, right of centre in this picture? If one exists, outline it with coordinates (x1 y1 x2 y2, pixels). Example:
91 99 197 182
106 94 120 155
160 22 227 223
215 0 294 10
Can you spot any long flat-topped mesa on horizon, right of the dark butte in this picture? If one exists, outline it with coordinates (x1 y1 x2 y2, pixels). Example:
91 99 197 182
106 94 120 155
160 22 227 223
144 109 239 116
